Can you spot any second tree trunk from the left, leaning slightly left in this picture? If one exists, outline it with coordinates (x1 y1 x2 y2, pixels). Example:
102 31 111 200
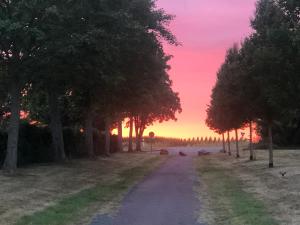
48 90 66 162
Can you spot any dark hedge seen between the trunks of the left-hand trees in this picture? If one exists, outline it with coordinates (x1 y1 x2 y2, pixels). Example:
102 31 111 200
0 122 118 167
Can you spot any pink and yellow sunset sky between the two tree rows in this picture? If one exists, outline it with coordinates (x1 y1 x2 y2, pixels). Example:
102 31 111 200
120 0 256 138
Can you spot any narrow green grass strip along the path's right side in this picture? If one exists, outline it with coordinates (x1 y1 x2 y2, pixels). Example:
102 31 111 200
199 160 278 225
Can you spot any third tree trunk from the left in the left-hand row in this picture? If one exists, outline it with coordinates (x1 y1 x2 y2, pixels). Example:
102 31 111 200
84 109 95 159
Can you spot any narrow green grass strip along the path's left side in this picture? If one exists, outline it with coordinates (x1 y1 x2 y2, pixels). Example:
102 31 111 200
16 157 159 225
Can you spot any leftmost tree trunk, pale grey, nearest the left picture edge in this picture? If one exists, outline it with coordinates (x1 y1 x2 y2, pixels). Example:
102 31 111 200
3 82 20 173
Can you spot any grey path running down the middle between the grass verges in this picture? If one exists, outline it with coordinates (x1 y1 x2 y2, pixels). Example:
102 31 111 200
91 152 205 225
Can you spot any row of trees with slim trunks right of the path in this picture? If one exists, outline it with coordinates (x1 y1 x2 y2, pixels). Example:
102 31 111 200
206 0 300 167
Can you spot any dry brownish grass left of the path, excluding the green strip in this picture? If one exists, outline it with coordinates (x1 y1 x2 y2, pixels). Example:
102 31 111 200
0 154 163 225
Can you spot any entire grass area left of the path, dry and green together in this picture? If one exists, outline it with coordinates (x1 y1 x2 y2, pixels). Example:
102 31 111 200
0 153 165 225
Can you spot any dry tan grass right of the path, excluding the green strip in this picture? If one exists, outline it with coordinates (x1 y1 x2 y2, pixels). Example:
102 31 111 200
198 150 300 225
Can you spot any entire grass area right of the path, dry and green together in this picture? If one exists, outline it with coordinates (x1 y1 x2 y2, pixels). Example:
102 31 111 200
195 150 300 225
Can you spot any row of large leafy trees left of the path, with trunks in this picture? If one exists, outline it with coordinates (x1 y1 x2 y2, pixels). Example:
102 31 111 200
0 0 181 171
